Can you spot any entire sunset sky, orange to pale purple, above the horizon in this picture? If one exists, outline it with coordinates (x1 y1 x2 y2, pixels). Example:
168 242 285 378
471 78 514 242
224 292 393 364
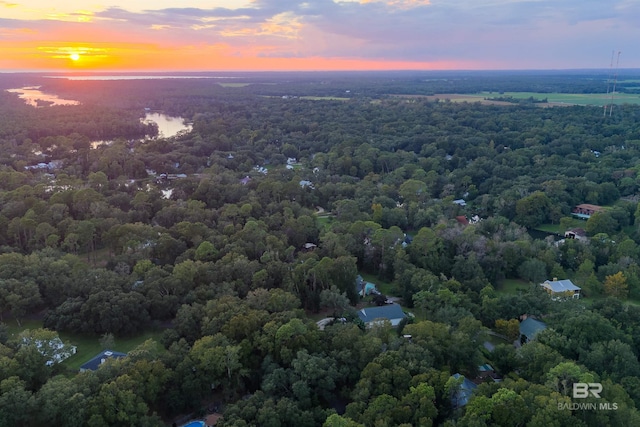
0 0 640 71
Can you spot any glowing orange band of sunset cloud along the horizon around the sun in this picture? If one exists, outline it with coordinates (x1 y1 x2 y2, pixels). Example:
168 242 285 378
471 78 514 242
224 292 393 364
0 37 471 71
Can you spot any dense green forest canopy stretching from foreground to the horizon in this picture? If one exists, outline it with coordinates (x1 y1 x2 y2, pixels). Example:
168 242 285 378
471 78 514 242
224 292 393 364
0 70 640 426
